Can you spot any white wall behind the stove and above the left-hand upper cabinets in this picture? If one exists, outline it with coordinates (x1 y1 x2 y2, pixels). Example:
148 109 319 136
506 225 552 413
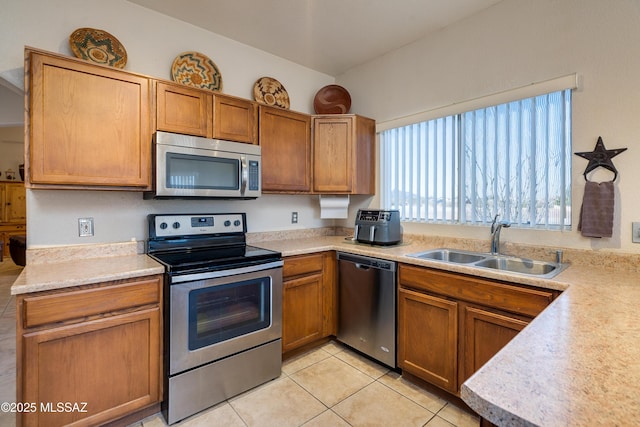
0 0 334 247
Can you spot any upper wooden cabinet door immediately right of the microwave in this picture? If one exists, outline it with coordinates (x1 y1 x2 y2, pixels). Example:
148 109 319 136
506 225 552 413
259 105 311 192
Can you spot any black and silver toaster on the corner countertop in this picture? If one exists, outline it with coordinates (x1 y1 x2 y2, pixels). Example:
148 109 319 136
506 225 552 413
353 209 402 246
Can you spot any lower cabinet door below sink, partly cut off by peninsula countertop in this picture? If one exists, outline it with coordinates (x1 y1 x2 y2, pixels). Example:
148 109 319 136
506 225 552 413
459 306 530 384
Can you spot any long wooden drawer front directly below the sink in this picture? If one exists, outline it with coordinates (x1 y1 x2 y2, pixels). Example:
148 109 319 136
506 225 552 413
398 264 554 317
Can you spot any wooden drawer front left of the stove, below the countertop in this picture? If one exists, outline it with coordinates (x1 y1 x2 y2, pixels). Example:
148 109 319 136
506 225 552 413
22 277 161 328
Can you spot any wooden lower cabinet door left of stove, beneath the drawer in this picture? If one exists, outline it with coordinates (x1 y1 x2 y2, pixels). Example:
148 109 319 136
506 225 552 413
20 307 161 426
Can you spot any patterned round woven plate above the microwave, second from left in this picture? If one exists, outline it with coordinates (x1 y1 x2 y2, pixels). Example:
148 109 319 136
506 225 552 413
171 52 222 91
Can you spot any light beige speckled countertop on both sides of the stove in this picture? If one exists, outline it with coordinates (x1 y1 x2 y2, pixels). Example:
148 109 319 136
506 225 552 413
11 235 640 427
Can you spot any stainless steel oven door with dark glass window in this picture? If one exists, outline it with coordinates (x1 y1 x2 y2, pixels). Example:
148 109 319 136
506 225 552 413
169 261 282 375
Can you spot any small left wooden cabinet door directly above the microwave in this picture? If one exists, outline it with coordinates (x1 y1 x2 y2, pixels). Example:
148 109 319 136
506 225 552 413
156 82 212 138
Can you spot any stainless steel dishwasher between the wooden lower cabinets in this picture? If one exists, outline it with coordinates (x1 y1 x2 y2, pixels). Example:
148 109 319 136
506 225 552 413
337 252 396 368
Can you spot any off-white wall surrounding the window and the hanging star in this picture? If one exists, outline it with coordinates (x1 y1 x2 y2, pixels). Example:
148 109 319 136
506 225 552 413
336 0 640 252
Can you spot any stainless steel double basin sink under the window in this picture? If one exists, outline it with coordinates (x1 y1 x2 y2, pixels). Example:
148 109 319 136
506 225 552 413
407 248 568 279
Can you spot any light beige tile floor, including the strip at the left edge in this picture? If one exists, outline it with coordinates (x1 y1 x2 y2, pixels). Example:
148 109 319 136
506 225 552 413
0 261 479 427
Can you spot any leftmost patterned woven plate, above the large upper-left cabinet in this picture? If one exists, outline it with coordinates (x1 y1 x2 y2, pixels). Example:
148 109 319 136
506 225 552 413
69 28 127 68
